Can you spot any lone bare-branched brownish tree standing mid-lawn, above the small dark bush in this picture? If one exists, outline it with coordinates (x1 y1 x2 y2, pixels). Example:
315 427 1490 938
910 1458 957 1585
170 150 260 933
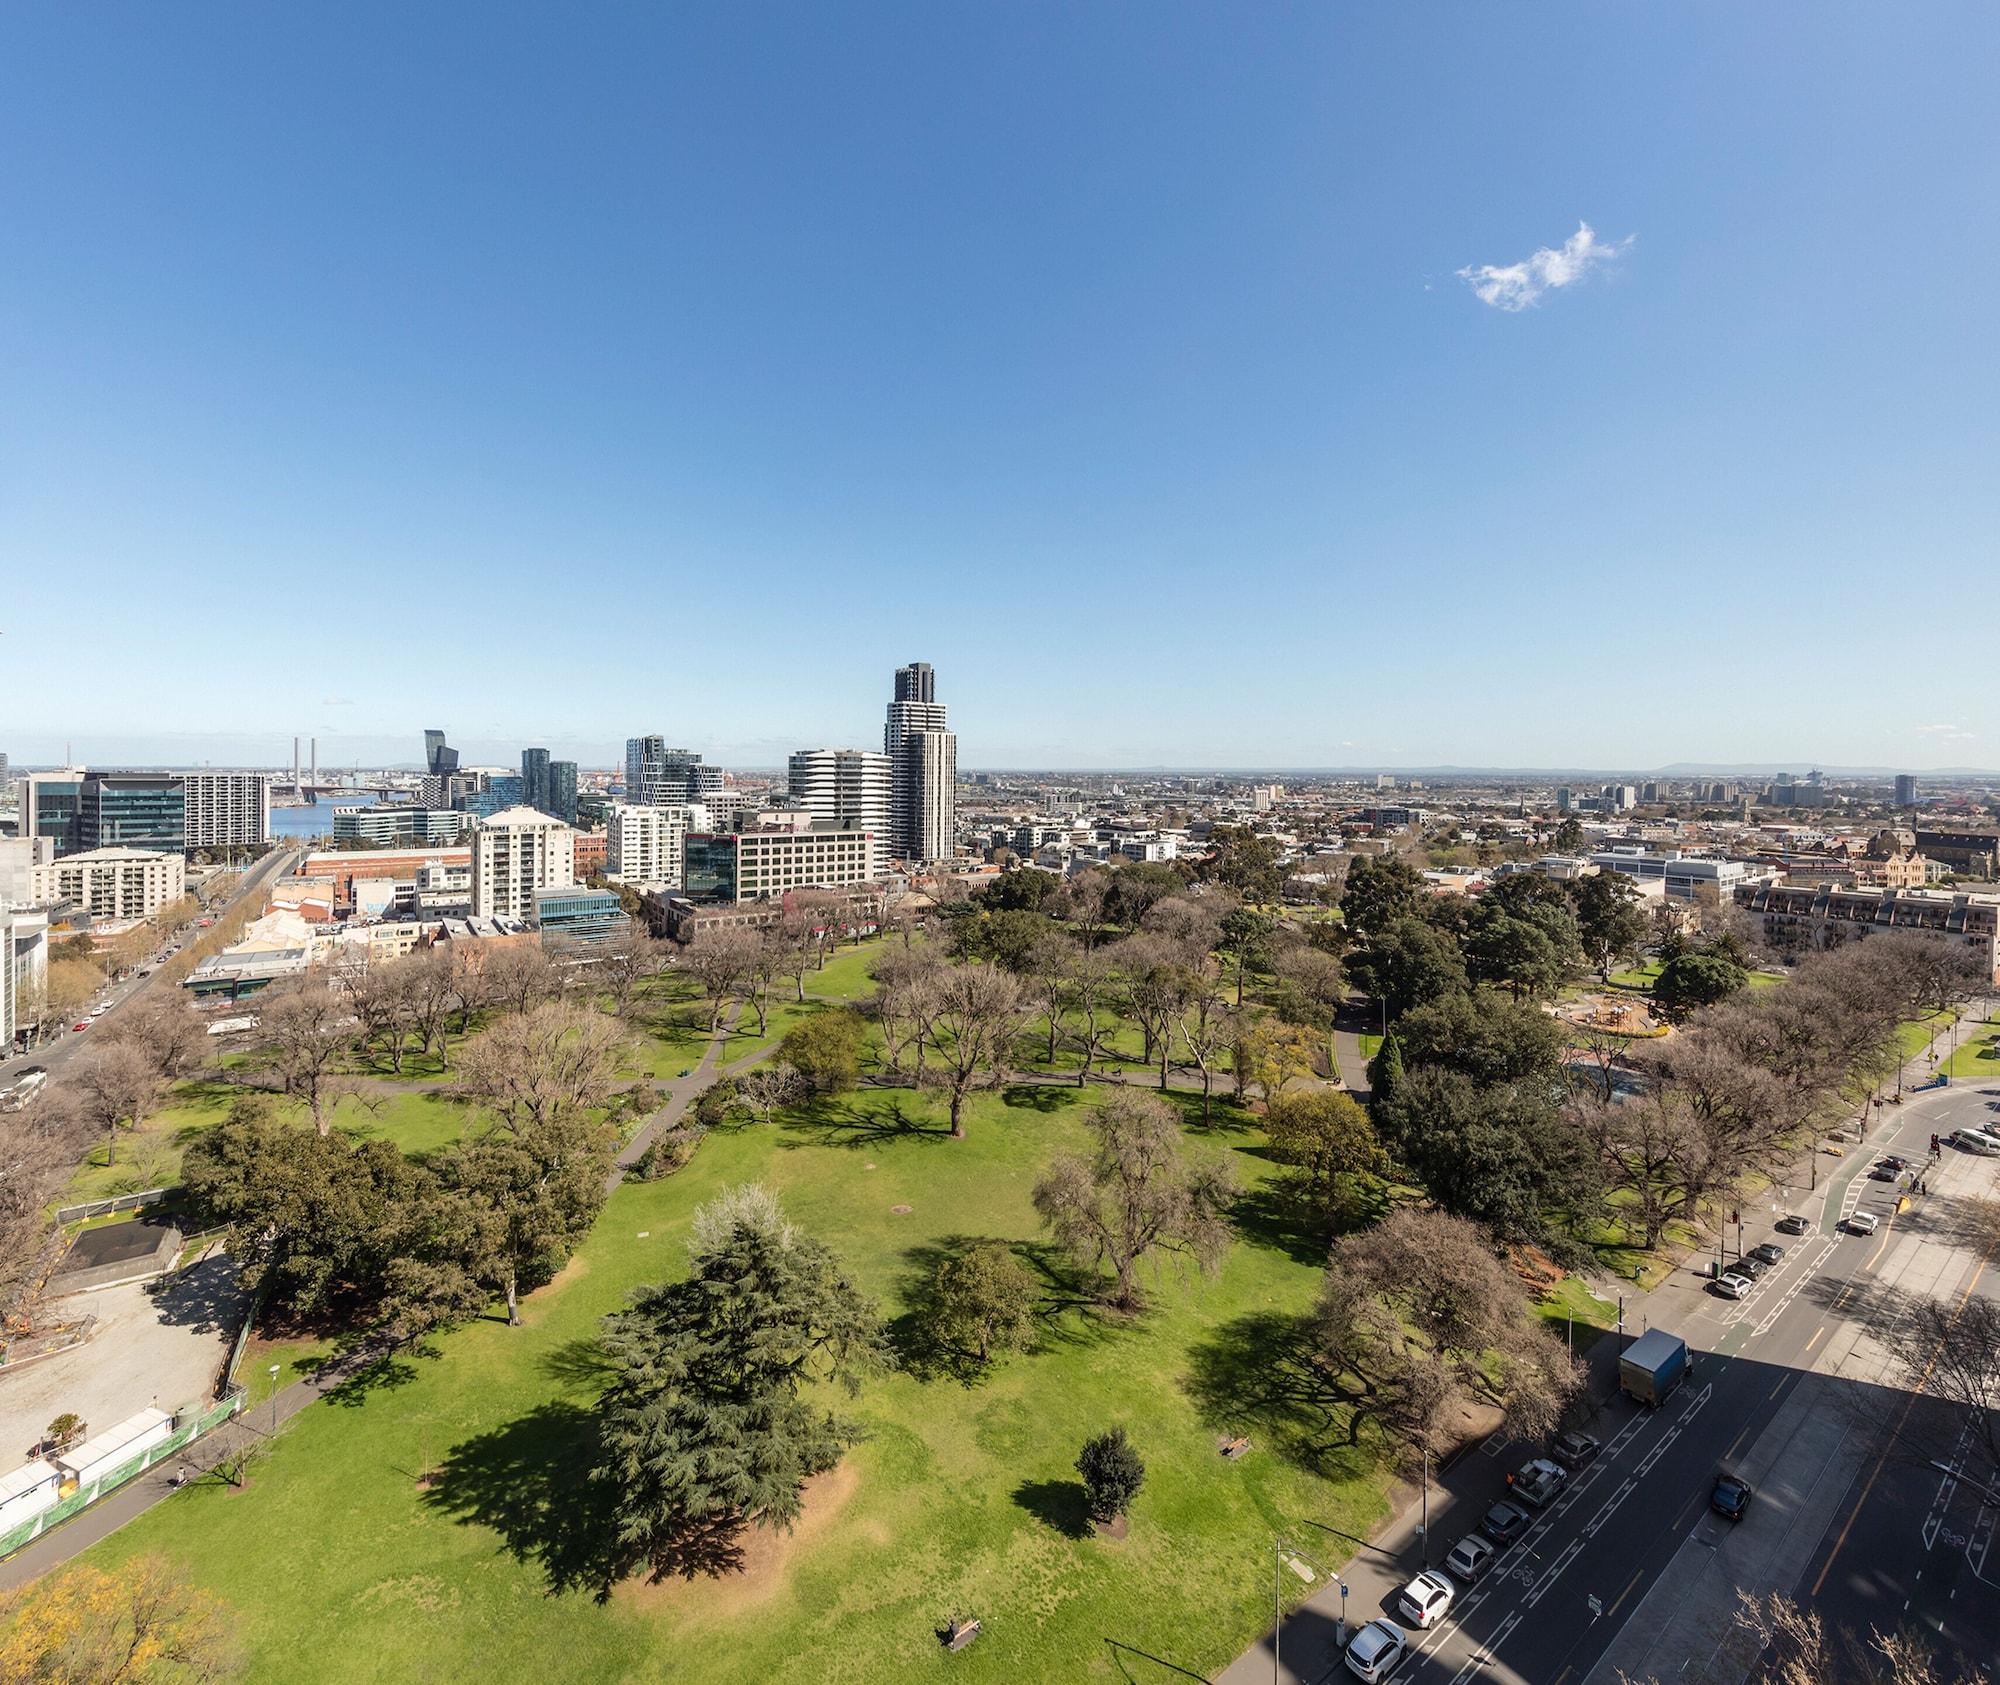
1034 1089 1236 1311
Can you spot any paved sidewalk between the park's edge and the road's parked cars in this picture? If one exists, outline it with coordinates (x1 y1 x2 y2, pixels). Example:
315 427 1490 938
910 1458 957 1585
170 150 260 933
1216 1001 1986 1685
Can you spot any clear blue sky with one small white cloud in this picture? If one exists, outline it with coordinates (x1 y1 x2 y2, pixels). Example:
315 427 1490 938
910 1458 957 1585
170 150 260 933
0 0 2000 768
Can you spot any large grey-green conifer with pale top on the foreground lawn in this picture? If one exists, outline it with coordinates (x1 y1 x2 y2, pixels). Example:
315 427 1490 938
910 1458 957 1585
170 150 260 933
596 1185 888 1579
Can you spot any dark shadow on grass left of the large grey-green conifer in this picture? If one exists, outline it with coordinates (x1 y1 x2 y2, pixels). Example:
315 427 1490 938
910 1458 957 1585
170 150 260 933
424 1403 624 1603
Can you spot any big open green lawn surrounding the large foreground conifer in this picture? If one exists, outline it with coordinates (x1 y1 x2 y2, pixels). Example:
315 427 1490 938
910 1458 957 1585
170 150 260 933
82 1089 1382 1685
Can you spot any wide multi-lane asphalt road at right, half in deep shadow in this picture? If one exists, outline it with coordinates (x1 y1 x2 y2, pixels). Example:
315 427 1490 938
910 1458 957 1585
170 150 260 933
1222 1004 2000 1685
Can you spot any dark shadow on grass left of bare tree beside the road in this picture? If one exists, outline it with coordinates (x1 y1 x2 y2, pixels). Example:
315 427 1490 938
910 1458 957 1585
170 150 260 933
1182 1311 1368 1473
